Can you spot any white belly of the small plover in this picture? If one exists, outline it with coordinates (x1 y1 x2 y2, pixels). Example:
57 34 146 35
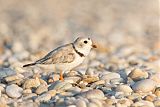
56 57 84 71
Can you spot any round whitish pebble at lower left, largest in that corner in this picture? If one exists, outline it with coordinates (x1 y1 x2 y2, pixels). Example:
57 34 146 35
6 84 23 98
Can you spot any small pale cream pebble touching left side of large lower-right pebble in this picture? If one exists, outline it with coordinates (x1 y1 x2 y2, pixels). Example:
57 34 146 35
116 85 133 93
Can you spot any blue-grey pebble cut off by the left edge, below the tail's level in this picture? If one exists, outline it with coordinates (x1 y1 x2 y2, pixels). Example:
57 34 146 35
0 68 16 78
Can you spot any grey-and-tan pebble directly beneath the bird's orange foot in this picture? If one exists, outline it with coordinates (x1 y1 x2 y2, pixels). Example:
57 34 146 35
48 81 72 91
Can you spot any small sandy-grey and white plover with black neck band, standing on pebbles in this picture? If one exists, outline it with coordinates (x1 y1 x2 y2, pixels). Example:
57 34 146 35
23 37 97 81
